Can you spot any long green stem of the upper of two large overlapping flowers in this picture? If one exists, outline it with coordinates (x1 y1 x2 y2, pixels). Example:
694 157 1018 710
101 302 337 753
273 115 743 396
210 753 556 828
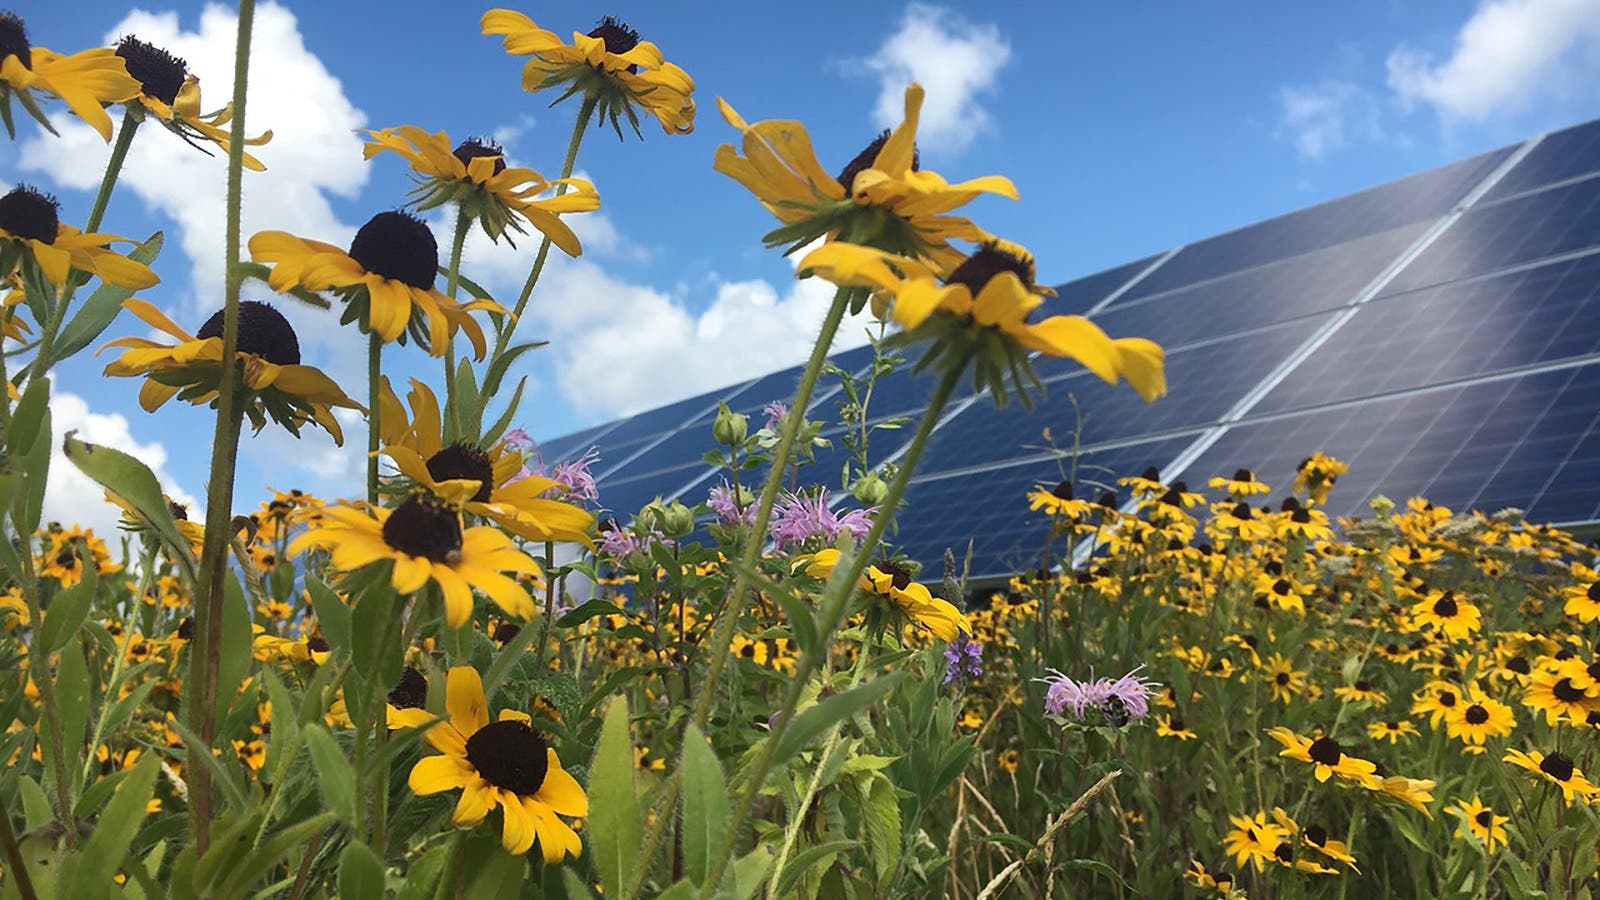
622 288 853 898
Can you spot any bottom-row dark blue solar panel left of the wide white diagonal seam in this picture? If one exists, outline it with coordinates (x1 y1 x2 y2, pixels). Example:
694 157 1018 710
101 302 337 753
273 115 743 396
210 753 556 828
896 440 1189 578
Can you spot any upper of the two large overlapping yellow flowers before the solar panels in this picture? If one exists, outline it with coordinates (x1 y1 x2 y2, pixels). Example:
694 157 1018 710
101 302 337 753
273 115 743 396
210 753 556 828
714 83 1018 271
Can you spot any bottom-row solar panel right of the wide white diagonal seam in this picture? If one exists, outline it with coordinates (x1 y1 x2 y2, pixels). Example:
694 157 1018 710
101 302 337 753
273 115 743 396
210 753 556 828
1184 364 1600 522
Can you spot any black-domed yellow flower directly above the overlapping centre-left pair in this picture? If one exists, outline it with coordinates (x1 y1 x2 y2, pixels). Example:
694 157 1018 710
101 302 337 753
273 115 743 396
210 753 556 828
250 211 506 359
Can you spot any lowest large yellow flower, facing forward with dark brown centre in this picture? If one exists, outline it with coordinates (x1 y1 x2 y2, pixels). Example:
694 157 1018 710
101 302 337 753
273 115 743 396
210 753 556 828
408 666 589 865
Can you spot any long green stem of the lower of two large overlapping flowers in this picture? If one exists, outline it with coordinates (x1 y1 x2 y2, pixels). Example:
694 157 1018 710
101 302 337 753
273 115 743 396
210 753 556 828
699 365 966 900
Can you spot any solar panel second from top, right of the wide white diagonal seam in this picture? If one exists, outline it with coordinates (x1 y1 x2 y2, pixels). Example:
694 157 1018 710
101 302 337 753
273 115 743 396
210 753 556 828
1384 171 1600 293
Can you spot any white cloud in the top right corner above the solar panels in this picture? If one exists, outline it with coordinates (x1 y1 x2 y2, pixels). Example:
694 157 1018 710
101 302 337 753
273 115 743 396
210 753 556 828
1387 0 1600 123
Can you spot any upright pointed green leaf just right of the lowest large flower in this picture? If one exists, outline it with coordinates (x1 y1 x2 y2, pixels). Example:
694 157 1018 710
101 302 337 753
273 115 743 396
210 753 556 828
589 697 645 895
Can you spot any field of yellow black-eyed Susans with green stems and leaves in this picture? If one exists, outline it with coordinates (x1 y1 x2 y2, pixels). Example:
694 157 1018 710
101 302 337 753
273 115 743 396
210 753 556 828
0 0 1600 898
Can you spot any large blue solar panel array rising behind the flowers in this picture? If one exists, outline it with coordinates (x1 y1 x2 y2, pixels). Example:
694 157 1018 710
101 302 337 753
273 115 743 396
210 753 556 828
541 120 1600 578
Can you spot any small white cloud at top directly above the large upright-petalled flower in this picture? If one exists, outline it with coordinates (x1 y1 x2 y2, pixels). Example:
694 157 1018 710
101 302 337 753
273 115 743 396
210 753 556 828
861 3 1011 152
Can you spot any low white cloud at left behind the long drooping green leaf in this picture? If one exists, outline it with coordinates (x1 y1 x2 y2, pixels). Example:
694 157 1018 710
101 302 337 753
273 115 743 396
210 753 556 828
43 391 203 544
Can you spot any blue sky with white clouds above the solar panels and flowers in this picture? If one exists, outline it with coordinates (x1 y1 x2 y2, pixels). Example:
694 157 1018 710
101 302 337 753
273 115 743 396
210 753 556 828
0 0 1600 525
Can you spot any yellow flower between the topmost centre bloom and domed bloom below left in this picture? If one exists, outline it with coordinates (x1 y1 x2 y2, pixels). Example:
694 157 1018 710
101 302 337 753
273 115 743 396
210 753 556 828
363 125 600 245
